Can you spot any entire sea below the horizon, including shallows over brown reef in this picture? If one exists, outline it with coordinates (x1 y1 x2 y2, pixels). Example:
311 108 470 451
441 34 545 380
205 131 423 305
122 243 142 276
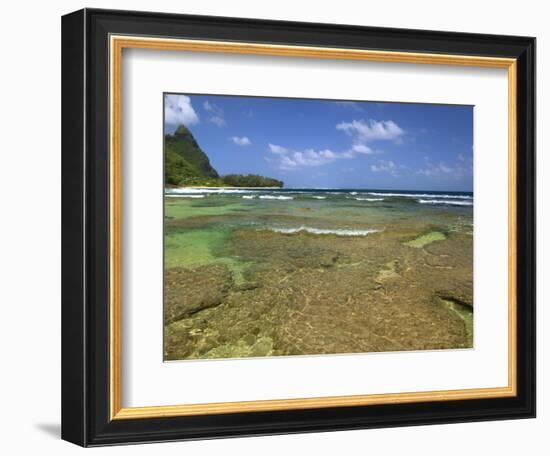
164 189 474 360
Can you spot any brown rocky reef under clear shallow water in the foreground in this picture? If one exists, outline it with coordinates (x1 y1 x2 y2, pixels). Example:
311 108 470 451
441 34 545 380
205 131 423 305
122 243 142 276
164 226 473 360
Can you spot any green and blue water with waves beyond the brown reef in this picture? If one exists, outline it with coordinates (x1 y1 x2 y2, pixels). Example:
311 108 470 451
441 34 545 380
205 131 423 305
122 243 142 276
165 188 474 278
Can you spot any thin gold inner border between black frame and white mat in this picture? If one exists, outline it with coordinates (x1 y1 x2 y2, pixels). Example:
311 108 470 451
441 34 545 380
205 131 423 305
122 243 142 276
109 35 517 420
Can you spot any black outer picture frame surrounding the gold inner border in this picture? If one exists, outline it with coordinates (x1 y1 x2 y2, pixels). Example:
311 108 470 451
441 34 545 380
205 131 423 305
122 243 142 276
62 9 535 446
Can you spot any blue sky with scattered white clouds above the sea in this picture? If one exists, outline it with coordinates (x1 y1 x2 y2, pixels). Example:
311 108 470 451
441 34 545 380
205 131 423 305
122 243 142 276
164 94 473 191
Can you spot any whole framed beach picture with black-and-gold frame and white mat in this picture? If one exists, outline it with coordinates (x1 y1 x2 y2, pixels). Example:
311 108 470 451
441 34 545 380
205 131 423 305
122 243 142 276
62 9 535 446
